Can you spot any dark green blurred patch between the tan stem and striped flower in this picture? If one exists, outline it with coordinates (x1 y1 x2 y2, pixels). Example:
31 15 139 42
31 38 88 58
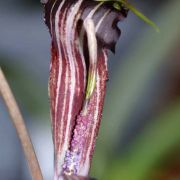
0 55 49 116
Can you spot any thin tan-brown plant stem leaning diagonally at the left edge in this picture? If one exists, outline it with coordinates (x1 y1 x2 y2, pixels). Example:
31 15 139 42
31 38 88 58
0 67 43 180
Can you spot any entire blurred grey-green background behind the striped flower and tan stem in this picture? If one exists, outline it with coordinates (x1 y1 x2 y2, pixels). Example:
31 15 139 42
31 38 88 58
0 0 180 180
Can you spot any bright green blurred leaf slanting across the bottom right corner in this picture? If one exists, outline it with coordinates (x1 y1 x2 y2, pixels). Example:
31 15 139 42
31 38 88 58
102 101 180 180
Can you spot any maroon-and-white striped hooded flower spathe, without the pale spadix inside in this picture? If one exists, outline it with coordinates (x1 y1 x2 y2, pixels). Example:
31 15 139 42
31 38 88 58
42 0 127 179
